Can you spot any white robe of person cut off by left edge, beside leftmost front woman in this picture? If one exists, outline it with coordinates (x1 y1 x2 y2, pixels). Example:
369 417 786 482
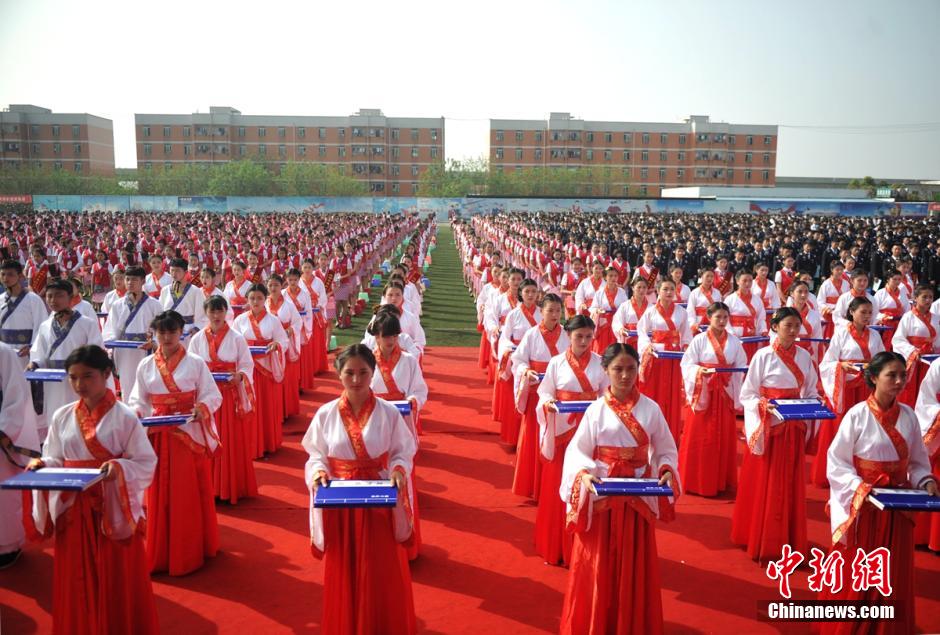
0 343 39 554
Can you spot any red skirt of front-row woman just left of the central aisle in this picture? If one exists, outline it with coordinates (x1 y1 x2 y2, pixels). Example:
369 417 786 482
321 508 417 635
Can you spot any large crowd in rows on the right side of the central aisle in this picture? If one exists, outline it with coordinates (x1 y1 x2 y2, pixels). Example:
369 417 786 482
455 214 940 633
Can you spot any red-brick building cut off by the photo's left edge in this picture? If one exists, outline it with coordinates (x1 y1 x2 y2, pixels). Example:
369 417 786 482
0 104 114 175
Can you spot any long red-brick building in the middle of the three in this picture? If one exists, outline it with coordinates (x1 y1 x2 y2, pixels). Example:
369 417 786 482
134 106 444 196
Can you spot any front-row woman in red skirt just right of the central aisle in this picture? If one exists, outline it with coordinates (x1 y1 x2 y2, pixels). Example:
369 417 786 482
559 344 679 635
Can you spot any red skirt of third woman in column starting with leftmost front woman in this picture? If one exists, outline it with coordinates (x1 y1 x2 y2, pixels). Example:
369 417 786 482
210 386 258 505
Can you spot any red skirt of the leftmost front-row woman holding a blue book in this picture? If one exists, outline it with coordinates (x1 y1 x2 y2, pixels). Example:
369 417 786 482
52 485 160 635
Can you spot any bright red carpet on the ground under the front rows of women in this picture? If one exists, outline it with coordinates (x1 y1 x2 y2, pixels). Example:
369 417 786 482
0 347 940 635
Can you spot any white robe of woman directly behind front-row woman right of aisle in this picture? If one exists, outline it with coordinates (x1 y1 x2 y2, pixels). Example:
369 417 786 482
535 352 610 461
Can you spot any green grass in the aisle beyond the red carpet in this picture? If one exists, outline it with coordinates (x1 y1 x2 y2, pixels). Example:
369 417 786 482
333 225 480 347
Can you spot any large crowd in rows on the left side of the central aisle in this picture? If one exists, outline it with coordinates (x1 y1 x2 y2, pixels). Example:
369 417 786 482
0 213 435 633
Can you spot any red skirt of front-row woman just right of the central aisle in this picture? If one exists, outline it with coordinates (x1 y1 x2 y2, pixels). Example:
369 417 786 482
560 499 663 635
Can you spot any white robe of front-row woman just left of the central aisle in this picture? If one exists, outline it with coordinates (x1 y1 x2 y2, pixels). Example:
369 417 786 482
301 398 417 552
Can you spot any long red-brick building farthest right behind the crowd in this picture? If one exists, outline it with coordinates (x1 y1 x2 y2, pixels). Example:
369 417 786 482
490 113 777 196
